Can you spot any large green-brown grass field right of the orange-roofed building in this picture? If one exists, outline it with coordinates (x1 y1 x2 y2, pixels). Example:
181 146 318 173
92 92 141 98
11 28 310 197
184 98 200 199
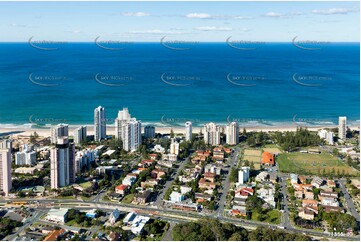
276 152 359 175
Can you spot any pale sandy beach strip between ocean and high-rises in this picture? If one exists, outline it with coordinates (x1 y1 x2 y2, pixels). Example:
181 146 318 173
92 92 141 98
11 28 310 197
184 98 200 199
0 124 360 137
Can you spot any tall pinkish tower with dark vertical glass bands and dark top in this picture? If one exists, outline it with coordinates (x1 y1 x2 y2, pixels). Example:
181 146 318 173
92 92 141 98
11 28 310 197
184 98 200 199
50 137 75 189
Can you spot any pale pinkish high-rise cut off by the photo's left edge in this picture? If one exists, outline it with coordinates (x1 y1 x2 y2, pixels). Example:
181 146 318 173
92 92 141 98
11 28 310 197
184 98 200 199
0 140 12 196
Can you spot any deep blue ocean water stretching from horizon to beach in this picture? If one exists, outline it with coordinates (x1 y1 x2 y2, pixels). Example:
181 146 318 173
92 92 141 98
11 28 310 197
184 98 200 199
0 43 360 126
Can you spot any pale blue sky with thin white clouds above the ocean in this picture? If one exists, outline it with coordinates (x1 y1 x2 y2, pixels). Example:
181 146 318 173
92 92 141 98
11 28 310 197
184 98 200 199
0 1 360 42
